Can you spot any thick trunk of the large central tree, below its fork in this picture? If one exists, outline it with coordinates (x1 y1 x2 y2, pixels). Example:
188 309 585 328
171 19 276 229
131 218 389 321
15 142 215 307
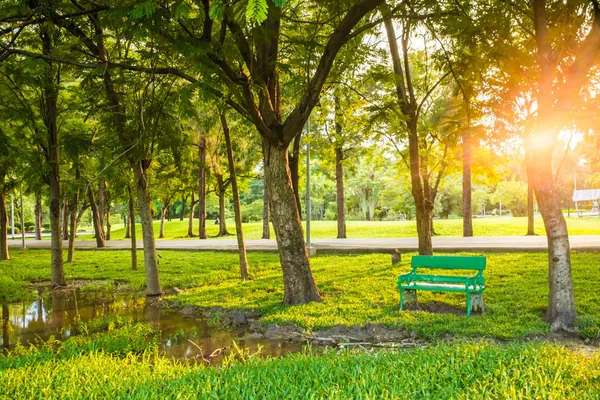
263 139 321 304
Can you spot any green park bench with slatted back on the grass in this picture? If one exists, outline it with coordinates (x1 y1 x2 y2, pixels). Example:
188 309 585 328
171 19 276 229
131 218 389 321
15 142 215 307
398 256 485 316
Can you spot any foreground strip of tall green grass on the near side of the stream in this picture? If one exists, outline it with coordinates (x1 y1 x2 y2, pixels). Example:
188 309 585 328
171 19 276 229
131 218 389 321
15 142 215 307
0 326 600 399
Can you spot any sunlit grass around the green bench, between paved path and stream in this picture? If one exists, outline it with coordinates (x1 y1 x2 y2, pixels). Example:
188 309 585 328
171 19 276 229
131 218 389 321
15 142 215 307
0 250 600 339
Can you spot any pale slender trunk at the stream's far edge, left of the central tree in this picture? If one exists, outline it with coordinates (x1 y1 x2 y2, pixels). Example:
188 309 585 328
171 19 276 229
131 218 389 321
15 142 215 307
132 163 162 296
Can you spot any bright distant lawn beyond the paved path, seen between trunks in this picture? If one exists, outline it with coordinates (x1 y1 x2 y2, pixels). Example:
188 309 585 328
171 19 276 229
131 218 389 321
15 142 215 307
108 217 600 240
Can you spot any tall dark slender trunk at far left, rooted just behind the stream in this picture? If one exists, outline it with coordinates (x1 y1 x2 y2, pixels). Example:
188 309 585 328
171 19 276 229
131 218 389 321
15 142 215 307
41 28 67 286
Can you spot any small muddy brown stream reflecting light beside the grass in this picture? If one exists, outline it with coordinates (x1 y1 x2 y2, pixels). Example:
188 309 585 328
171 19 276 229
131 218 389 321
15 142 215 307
0 290 302 363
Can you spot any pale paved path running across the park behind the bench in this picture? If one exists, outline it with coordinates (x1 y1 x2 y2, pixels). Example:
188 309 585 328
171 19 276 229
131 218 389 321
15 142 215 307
9 236 600 253
